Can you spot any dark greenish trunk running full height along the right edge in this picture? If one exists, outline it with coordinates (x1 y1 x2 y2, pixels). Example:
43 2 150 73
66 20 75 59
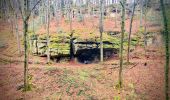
160 0 170 100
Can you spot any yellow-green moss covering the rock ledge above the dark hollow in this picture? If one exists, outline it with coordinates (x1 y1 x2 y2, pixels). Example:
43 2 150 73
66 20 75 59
32 30 139 55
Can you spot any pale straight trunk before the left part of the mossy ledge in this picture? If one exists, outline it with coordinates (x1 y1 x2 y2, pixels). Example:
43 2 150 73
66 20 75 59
47 0 50 63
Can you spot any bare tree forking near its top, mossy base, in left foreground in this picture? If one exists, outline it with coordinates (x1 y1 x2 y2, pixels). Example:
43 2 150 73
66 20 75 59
18 0 41 91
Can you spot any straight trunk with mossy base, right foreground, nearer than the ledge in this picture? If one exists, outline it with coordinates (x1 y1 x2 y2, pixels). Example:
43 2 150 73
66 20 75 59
119 0 126 88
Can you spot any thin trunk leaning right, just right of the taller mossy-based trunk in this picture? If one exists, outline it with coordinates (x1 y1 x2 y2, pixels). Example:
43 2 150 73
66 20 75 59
127 2 136 63
